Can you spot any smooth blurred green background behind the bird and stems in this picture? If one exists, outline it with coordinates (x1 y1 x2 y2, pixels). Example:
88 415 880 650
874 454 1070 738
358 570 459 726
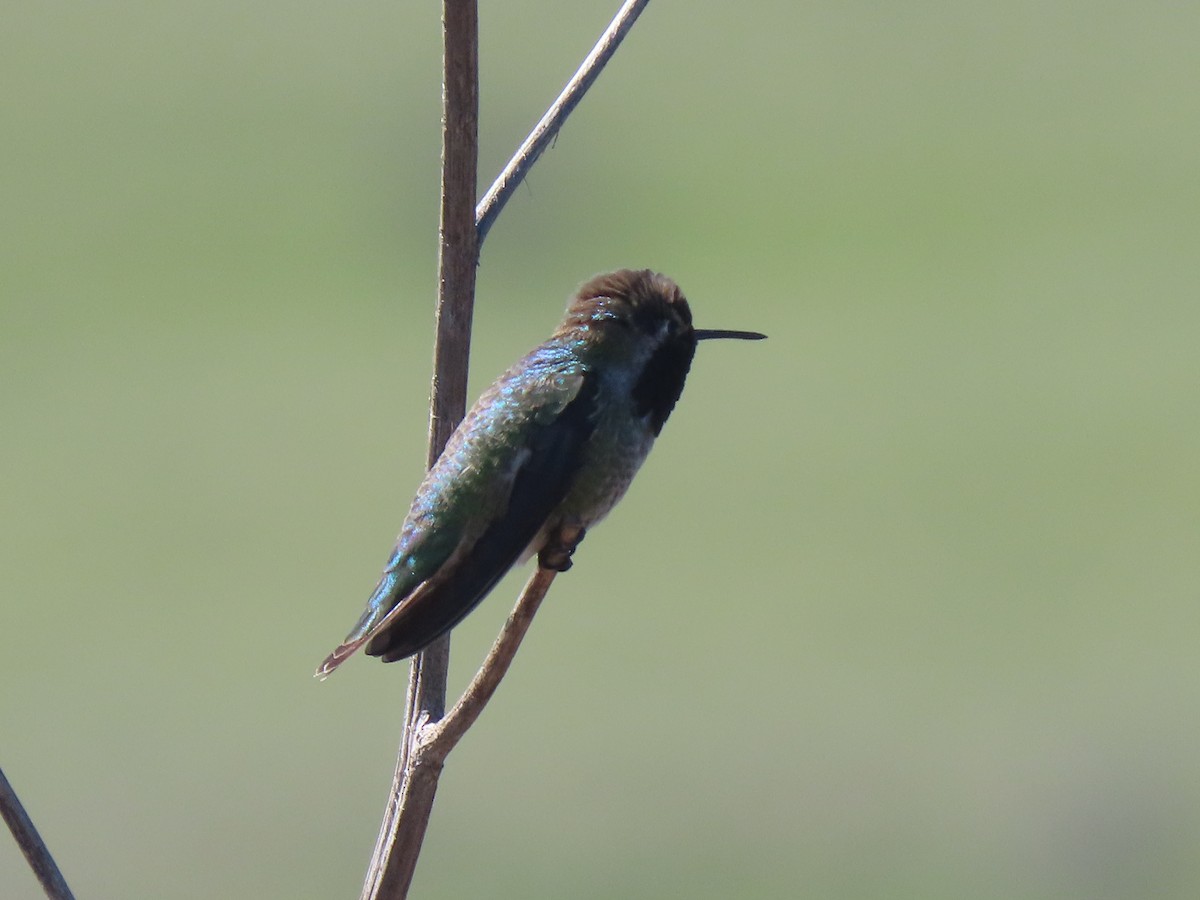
0 0 1200 900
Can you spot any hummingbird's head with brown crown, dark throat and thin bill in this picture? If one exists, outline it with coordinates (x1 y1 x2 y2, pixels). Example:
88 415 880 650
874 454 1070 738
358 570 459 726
556 269 766 434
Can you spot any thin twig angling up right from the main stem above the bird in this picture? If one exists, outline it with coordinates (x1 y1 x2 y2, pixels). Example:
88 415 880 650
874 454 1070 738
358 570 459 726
475 0 650 245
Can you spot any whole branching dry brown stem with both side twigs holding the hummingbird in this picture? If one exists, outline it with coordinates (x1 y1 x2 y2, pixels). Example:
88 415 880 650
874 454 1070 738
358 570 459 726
362 0 649 900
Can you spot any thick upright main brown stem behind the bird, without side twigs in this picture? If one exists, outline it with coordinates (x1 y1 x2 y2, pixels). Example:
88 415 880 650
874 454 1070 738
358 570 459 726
361 0 479 900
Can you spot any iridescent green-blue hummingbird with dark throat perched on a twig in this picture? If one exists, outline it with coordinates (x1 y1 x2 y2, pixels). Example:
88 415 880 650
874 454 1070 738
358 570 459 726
317 269 766 678
